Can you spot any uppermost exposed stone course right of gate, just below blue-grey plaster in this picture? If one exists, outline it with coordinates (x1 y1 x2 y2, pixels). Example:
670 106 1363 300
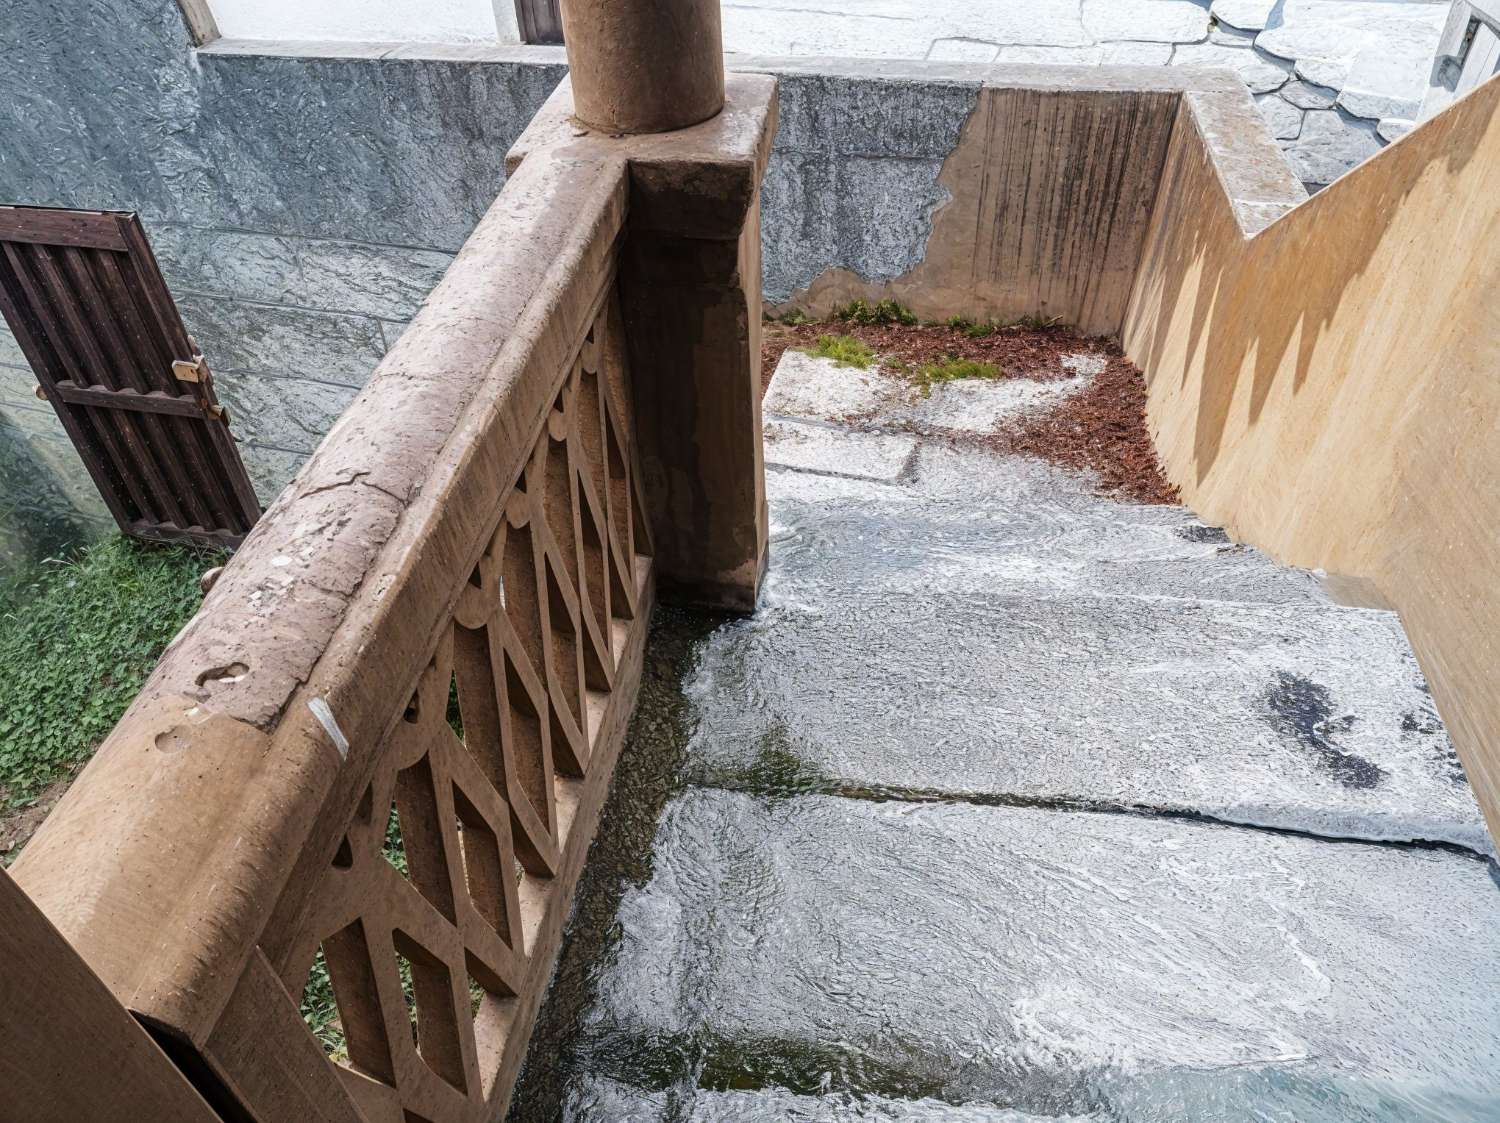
147 222 453 321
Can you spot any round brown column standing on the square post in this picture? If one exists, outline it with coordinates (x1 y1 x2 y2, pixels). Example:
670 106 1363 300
563 0 725 132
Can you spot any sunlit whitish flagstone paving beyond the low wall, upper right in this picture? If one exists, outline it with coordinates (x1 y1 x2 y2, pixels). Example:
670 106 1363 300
723 0 1449 186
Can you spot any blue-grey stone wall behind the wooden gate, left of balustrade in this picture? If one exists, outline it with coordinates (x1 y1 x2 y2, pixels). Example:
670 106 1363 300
0 0 566 568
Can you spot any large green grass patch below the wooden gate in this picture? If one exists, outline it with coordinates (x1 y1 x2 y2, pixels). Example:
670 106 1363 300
0 537 224 811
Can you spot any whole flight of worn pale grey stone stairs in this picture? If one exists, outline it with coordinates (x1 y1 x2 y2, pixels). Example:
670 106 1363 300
512 355 1500 1123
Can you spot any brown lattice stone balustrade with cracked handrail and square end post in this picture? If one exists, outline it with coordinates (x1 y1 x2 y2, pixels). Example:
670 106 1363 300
11 75 776 1123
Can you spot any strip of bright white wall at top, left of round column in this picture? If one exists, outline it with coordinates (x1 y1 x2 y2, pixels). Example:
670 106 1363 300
210 0 519 43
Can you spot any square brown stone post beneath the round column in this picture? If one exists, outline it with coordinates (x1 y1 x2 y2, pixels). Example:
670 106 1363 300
509 75 776 612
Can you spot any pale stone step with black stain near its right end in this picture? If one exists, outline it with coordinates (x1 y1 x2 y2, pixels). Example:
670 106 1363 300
686 582 1493 853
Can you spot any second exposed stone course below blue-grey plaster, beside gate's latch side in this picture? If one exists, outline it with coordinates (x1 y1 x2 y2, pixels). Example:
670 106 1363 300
177 295 386 385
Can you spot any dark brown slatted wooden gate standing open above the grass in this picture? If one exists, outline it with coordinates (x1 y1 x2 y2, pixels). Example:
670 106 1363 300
0 207 261 546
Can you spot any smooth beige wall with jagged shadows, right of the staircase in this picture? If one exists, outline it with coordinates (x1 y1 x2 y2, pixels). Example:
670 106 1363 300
1122 72 1500 835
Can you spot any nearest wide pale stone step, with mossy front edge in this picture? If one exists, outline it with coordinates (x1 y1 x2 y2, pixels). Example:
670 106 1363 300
570 789 1500 1123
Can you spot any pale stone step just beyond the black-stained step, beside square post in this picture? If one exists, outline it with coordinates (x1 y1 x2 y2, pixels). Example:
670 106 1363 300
767 443 1329 604
